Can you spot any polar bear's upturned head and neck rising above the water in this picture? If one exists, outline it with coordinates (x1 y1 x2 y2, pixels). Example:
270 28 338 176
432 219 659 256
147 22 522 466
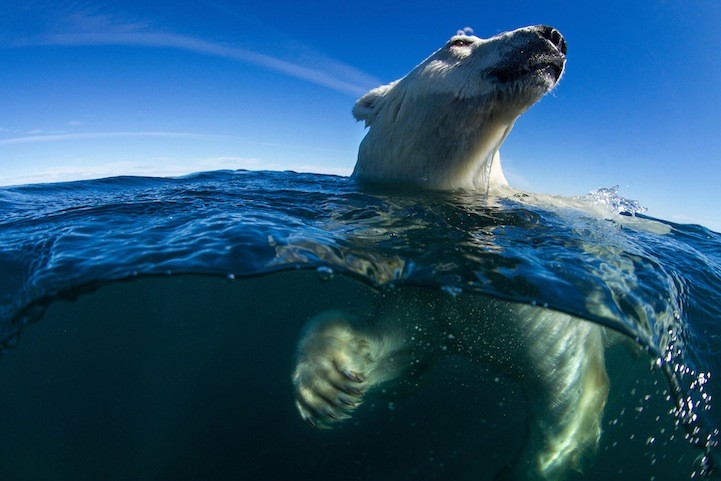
353 26 566 190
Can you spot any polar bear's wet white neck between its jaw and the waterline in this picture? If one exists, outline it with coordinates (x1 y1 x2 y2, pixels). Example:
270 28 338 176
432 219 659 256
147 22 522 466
353 91 515 192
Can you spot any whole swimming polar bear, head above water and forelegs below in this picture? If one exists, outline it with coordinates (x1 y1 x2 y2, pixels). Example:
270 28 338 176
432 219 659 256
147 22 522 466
292 26 609 481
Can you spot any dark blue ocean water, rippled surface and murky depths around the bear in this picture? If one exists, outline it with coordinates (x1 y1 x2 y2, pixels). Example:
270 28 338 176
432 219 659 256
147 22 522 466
0 171 721 481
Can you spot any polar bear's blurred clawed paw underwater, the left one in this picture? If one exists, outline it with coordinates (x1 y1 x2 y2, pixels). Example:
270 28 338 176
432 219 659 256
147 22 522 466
292 314 379 428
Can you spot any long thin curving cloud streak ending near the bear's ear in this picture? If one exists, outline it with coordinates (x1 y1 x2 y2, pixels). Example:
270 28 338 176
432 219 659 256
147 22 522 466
11 12 380 95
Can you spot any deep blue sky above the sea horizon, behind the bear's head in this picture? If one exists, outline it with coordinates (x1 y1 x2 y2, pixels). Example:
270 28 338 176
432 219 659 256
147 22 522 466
0 0 721 231
